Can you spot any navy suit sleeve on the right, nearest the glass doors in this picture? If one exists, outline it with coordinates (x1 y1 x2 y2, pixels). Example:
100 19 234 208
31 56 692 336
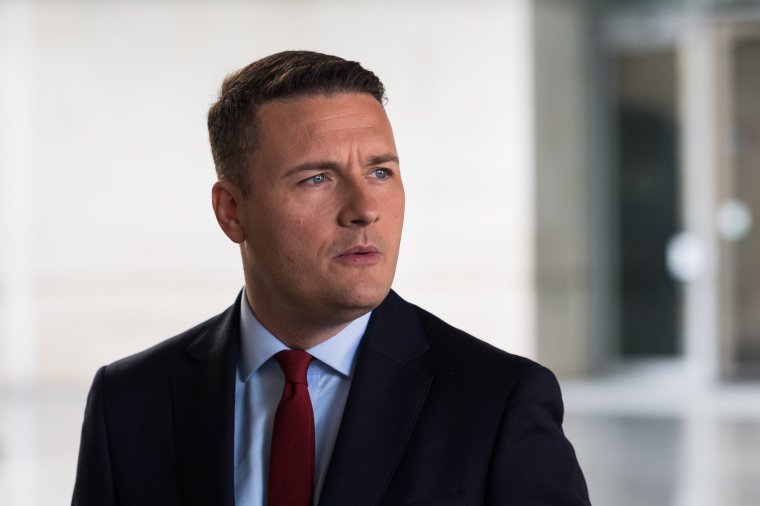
486 364 590 506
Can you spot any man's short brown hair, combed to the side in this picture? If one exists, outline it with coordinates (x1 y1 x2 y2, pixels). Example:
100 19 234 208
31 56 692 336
208 51 385 197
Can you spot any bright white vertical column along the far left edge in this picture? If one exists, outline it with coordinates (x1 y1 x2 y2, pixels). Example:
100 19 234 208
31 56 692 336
0 0 37 385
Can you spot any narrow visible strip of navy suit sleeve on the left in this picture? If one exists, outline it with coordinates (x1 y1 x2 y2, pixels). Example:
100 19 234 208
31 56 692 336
71 367 116 506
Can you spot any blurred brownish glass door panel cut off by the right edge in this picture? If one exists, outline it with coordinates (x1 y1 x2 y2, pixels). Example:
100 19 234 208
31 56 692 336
716 22 760 379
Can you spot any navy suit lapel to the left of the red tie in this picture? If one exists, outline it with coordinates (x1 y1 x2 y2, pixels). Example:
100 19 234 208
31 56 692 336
172 297 240 506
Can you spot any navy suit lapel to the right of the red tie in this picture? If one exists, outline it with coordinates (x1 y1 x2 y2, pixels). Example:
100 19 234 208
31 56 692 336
319 292 433 506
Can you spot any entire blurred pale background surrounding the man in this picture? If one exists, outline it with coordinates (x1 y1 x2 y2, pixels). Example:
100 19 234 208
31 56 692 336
0 0 760 506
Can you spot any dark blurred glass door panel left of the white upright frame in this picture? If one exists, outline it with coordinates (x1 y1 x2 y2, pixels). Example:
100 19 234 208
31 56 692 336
612 50 681 359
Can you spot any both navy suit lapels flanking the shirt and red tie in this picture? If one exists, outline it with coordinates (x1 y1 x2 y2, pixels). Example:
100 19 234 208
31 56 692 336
172 291 433 506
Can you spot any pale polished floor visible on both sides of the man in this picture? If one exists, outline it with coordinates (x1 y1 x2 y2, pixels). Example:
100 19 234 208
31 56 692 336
0 386 760 506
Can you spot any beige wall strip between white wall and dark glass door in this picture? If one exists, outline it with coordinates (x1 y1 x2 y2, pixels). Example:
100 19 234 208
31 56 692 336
533 0 592 377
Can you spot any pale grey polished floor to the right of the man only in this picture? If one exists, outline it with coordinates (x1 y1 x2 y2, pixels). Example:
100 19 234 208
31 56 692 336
565 416 760 506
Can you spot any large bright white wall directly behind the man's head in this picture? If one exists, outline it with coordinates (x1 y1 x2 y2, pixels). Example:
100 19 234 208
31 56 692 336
0 0 534 383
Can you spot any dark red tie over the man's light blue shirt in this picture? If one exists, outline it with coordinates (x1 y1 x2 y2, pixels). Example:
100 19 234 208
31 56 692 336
267 350 314 506
